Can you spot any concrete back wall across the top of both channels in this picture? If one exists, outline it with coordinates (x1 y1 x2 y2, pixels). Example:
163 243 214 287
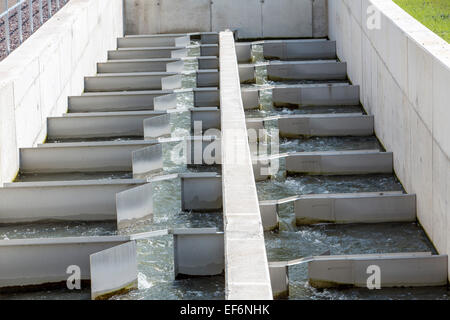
125 0 328 38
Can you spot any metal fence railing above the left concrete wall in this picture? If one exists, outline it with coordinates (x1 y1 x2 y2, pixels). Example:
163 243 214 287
0 0 69 60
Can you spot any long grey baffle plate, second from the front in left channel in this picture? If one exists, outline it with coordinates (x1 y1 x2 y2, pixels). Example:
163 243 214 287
0 179 151 223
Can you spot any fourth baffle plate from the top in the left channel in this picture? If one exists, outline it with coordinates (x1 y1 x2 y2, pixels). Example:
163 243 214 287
84 72 182 92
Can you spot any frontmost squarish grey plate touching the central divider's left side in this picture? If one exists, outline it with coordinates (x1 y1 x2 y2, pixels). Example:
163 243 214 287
171 229 225 278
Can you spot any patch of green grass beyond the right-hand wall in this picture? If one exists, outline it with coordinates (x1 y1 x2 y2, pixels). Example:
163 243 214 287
394 0 450 43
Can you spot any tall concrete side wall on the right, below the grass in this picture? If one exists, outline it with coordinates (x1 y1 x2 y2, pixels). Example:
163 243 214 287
328 0 450 276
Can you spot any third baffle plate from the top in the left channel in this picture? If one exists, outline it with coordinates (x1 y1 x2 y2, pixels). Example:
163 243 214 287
97 58 184 73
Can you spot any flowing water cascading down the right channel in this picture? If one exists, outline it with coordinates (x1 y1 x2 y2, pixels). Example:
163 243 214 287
243 45 449 300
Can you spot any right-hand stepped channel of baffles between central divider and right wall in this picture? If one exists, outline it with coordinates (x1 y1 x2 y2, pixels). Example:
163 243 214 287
237 40 447 299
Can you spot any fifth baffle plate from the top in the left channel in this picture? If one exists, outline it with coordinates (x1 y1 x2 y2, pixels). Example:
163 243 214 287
69 90 177 112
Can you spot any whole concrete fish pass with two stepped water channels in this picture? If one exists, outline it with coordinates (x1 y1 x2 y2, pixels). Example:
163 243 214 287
0 0 450 300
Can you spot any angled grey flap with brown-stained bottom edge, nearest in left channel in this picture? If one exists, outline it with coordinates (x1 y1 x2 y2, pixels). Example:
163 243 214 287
90 241 138 300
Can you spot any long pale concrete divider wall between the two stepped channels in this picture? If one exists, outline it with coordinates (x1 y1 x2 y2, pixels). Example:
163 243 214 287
220 31 273 300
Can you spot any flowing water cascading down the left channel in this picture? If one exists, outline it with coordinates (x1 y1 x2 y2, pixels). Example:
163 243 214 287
0 43 225 300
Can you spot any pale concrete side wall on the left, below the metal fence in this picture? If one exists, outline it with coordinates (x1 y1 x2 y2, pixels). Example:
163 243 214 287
0 0 123 184
